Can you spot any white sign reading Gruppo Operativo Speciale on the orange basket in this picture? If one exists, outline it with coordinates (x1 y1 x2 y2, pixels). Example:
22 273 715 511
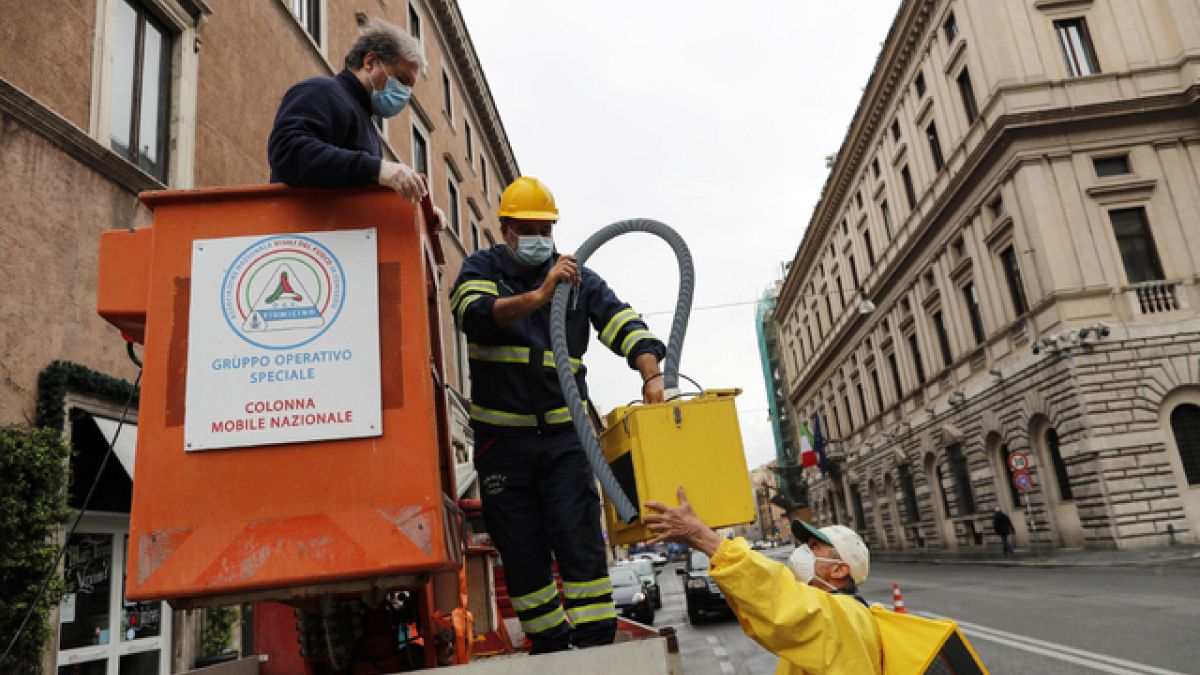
184 228 383 450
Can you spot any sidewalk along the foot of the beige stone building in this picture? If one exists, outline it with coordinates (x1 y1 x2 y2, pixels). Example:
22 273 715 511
871 544 1200 568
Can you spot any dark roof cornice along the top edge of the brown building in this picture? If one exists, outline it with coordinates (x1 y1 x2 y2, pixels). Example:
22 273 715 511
427 0 521 185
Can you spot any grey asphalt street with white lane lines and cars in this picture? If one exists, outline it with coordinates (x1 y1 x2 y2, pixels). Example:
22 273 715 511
655 548 1200 675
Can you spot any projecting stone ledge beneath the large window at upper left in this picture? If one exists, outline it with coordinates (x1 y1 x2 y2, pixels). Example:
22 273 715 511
0 77 167 195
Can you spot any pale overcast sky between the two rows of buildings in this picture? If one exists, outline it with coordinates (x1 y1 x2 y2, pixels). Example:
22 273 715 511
458 0 900 468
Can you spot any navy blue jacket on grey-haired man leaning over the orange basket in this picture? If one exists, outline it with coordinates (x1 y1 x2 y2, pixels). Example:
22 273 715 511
266 70 383 187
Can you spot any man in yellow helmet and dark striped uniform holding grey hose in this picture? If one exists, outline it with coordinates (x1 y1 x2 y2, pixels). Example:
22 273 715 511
450 177 666 653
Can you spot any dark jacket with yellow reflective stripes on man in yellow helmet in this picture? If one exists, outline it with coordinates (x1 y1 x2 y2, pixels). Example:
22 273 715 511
450 244 666 431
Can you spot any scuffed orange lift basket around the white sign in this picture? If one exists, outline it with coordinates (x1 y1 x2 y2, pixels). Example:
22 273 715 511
100 186 461 598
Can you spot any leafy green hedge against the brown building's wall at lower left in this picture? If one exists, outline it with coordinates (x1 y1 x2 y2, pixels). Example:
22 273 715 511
0 426 71 674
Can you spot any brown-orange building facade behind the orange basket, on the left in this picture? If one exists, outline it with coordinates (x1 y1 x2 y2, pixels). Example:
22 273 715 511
0 0 520 673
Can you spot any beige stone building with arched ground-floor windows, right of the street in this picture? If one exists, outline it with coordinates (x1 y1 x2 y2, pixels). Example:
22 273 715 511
776 0 1200 551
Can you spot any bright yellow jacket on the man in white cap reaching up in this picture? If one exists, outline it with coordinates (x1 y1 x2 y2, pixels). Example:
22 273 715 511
708 538 883 675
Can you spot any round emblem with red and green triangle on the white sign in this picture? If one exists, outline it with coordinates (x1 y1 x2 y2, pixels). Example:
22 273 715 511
221 235 346 350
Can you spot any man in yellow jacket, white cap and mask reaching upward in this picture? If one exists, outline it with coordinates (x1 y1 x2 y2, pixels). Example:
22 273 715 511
646 488 883 675
